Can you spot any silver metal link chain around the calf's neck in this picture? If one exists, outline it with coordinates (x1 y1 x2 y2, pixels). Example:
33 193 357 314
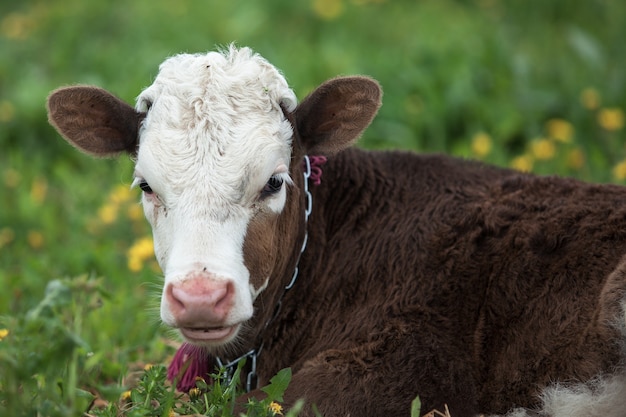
215 155 313 392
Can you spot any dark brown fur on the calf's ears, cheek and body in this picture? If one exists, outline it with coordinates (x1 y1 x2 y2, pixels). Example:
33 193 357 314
49 77 626 417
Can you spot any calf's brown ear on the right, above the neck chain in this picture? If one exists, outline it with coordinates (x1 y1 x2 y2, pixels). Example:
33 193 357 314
295 77 382 155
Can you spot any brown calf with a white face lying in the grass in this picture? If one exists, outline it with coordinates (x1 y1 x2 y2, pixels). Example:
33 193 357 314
48 47 626 417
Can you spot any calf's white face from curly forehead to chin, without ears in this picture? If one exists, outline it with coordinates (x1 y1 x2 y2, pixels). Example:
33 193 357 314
134 48 296 347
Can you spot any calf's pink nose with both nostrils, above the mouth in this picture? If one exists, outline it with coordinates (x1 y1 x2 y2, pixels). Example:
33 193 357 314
165 276 235 327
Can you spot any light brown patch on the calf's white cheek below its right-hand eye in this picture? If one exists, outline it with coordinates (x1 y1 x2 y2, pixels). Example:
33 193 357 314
243 211 278 291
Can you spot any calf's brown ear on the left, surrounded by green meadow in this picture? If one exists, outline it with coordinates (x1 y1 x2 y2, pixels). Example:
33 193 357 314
47 86 144 157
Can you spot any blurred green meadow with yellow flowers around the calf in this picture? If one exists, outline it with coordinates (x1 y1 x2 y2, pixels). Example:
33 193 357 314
0 0 626 416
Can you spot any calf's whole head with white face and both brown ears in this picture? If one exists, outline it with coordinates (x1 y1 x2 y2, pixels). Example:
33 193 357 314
48 47 381 352
